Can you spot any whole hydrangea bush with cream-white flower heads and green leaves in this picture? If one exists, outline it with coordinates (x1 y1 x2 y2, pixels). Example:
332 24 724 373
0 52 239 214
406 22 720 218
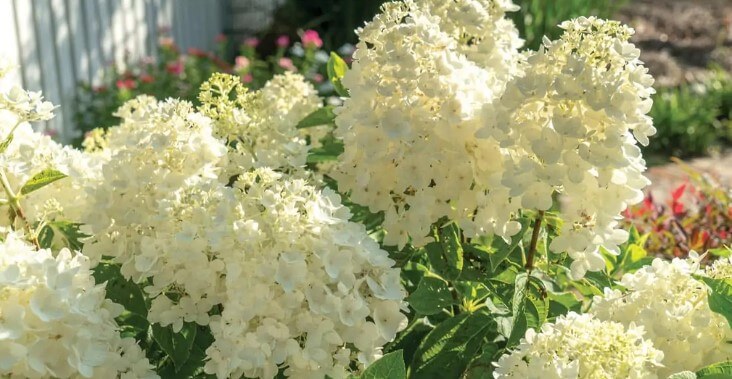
0 0 732 378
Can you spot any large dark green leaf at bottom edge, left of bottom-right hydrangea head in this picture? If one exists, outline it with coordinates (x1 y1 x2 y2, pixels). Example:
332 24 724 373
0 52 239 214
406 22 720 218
410 312 495 378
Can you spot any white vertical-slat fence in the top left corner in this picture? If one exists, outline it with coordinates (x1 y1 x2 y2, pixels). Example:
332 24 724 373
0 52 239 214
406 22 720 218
0 0 227 142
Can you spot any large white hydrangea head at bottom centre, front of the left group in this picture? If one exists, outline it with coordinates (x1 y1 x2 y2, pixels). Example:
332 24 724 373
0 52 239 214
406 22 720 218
206 169 407 378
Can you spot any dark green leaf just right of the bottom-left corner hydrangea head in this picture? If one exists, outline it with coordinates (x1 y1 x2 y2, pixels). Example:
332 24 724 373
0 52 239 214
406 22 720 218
93 262 147 318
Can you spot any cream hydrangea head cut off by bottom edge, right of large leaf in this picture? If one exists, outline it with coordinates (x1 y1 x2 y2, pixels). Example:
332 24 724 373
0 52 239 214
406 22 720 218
493 312 665 379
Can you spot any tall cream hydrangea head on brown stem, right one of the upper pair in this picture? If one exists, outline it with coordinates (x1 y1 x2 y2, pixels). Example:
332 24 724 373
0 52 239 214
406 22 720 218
479 17 655 279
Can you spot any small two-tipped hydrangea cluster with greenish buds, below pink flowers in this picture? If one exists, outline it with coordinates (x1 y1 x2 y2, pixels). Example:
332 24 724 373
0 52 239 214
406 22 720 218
199 72 322 176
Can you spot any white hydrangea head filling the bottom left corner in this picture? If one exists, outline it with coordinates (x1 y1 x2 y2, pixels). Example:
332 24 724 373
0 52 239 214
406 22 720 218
0 233 158 378
